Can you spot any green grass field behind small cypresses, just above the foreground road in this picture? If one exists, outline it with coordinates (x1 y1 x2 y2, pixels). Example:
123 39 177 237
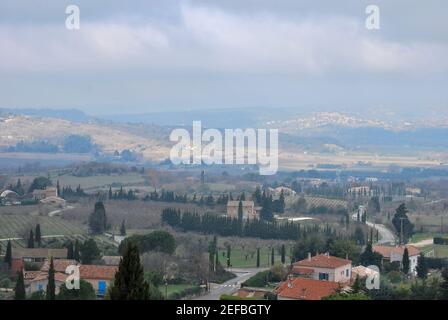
219 247 290 268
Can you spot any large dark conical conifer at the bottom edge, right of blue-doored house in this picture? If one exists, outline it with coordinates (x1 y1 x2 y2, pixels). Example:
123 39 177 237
109 242 161 300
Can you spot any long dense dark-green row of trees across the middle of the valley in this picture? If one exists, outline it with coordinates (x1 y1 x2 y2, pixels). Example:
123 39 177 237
162 208 333 240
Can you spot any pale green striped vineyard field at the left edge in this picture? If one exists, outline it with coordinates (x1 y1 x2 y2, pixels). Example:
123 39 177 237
0 215 87 252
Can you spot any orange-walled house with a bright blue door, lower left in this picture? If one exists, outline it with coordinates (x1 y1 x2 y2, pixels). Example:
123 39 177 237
79 265 118 297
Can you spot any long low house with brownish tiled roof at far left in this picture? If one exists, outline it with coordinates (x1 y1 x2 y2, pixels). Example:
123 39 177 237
11 248 68 273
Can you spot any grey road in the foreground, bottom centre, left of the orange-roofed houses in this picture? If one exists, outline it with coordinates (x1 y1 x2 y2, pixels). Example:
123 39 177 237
194 268 267 300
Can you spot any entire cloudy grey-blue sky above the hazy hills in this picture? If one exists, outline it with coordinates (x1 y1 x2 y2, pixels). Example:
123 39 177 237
0 0 448 115
